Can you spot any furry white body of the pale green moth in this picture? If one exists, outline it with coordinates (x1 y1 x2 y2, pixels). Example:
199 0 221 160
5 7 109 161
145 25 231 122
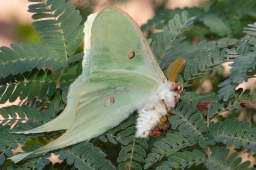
135 81 182 137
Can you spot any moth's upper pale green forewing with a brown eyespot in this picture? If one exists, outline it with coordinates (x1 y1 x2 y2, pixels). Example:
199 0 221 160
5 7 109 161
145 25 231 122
89 8 166 82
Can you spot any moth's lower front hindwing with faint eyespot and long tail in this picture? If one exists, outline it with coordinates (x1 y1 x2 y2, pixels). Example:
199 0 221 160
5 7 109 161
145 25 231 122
10 73 157 163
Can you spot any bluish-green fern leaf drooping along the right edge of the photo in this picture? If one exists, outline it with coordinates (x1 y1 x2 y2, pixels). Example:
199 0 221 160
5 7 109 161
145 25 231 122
219 25 256 101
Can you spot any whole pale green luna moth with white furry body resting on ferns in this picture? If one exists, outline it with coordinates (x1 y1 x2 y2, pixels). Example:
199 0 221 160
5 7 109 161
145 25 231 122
10 7 182 163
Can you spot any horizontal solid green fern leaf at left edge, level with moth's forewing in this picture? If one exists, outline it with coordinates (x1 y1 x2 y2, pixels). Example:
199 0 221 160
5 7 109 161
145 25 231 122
0 43 59 78
